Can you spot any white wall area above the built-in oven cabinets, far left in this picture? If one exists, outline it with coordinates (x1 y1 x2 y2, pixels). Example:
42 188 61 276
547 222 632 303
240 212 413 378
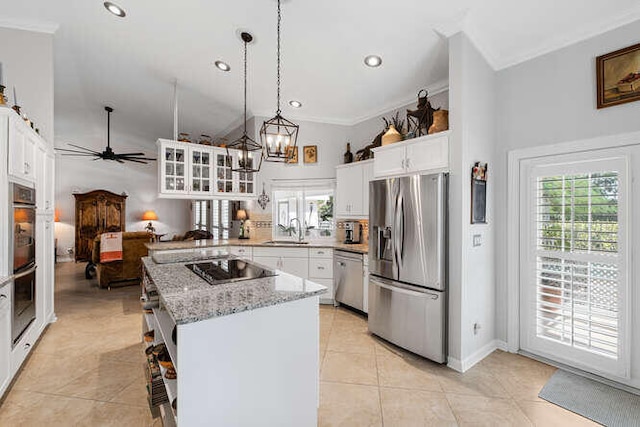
0 28 53 144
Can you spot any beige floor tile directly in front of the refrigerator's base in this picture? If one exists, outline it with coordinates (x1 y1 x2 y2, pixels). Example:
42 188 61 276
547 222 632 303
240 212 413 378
377 356 442 392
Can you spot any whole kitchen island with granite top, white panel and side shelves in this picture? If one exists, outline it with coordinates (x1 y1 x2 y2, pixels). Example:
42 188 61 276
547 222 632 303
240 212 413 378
143 253 326 426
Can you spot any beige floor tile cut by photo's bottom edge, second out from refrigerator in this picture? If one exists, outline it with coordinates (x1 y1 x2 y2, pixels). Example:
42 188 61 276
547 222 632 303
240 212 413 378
380 388 457 427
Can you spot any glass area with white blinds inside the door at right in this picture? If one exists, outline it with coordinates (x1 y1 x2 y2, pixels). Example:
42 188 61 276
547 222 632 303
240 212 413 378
534 171 621 359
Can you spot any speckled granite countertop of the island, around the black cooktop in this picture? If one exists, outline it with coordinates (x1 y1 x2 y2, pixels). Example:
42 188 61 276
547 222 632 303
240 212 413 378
142 257 327 325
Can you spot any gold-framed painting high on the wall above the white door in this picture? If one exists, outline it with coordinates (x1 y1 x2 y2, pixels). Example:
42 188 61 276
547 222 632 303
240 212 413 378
596 43 640 109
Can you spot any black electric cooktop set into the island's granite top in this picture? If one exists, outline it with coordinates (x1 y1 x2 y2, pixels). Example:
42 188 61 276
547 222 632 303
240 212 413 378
185 258 277 285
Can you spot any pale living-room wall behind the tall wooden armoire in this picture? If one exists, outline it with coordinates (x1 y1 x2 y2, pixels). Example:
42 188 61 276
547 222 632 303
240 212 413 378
55 118 191 259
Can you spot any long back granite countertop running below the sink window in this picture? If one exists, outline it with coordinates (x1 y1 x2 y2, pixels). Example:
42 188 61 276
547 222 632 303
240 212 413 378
145 239 369 254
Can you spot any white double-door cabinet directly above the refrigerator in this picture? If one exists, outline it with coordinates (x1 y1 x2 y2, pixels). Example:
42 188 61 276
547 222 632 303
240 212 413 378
373 131 449 178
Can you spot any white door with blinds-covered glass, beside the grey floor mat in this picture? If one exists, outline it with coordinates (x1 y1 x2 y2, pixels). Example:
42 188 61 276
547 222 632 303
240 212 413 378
520 153 630 378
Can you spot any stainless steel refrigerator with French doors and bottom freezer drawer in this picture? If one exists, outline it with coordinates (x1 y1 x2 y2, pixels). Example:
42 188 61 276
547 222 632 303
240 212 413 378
369 173 448 363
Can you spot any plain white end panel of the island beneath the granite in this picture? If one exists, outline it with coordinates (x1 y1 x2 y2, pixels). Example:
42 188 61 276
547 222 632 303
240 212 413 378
176 297 320 427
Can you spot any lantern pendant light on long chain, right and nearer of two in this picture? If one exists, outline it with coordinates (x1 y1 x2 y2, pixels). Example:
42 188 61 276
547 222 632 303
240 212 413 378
260 0 299 163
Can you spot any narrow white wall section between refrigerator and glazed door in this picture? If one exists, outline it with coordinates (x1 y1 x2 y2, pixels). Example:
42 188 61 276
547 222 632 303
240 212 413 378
449 33 496 370
